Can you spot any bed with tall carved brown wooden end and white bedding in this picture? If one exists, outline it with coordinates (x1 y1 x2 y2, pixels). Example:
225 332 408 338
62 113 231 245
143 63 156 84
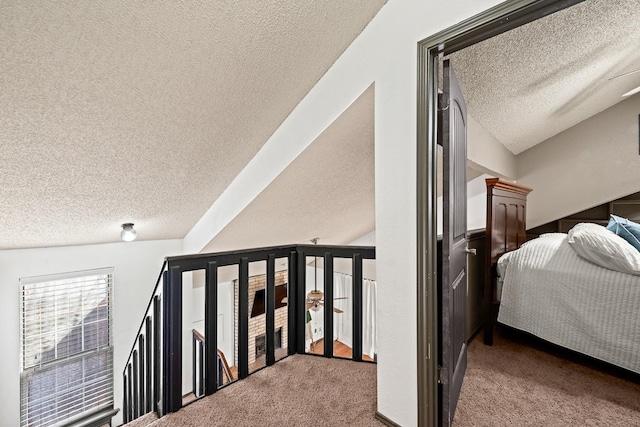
485 180 640 373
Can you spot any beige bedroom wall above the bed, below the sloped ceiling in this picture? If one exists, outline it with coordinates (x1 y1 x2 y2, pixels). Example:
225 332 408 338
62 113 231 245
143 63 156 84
517 95 640 228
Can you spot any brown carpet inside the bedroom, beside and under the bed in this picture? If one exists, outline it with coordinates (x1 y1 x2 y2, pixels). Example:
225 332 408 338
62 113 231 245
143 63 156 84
454 331 640 427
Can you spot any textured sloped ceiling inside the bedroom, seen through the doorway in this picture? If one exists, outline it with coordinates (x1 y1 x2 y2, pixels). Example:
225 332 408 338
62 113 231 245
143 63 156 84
451 0 640 154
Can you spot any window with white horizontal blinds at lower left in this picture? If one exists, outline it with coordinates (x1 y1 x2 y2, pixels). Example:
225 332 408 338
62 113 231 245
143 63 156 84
20 268 113 427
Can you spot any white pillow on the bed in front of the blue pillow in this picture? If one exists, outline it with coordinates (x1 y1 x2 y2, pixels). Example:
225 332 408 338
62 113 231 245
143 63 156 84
567 222 640 275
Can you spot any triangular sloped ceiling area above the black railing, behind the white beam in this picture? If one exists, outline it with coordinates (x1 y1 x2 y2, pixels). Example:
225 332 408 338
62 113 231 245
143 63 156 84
203 86 375 252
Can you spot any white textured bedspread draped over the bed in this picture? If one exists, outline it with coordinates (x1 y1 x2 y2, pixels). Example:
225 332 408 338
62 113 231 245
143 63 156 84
498 233 640 373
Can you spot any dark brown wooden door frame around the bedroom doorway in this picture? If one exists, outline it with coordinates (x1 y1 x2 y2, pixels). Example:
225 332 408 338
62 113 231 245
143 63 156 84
416 0 584 427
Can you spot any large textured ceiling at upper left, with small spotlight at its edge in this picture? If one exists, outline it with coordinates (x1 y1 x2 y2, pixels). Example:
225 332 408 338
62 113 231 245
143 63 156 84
0 0 385 249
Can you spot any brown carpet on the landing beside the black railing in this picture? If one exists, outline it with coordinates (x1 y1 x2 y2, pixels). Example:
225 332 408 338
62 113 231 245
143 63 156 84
128 355 383 427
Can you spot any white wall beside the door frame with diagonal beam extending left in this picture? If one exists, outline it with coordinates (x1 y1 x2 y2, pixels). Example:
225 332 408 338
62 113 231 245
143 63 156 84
184 0 500 427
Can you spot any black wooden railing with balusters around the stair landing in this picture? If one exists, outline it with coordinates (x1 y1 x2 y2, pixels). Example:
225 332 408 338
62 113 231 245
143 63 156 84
123 245 375 423
